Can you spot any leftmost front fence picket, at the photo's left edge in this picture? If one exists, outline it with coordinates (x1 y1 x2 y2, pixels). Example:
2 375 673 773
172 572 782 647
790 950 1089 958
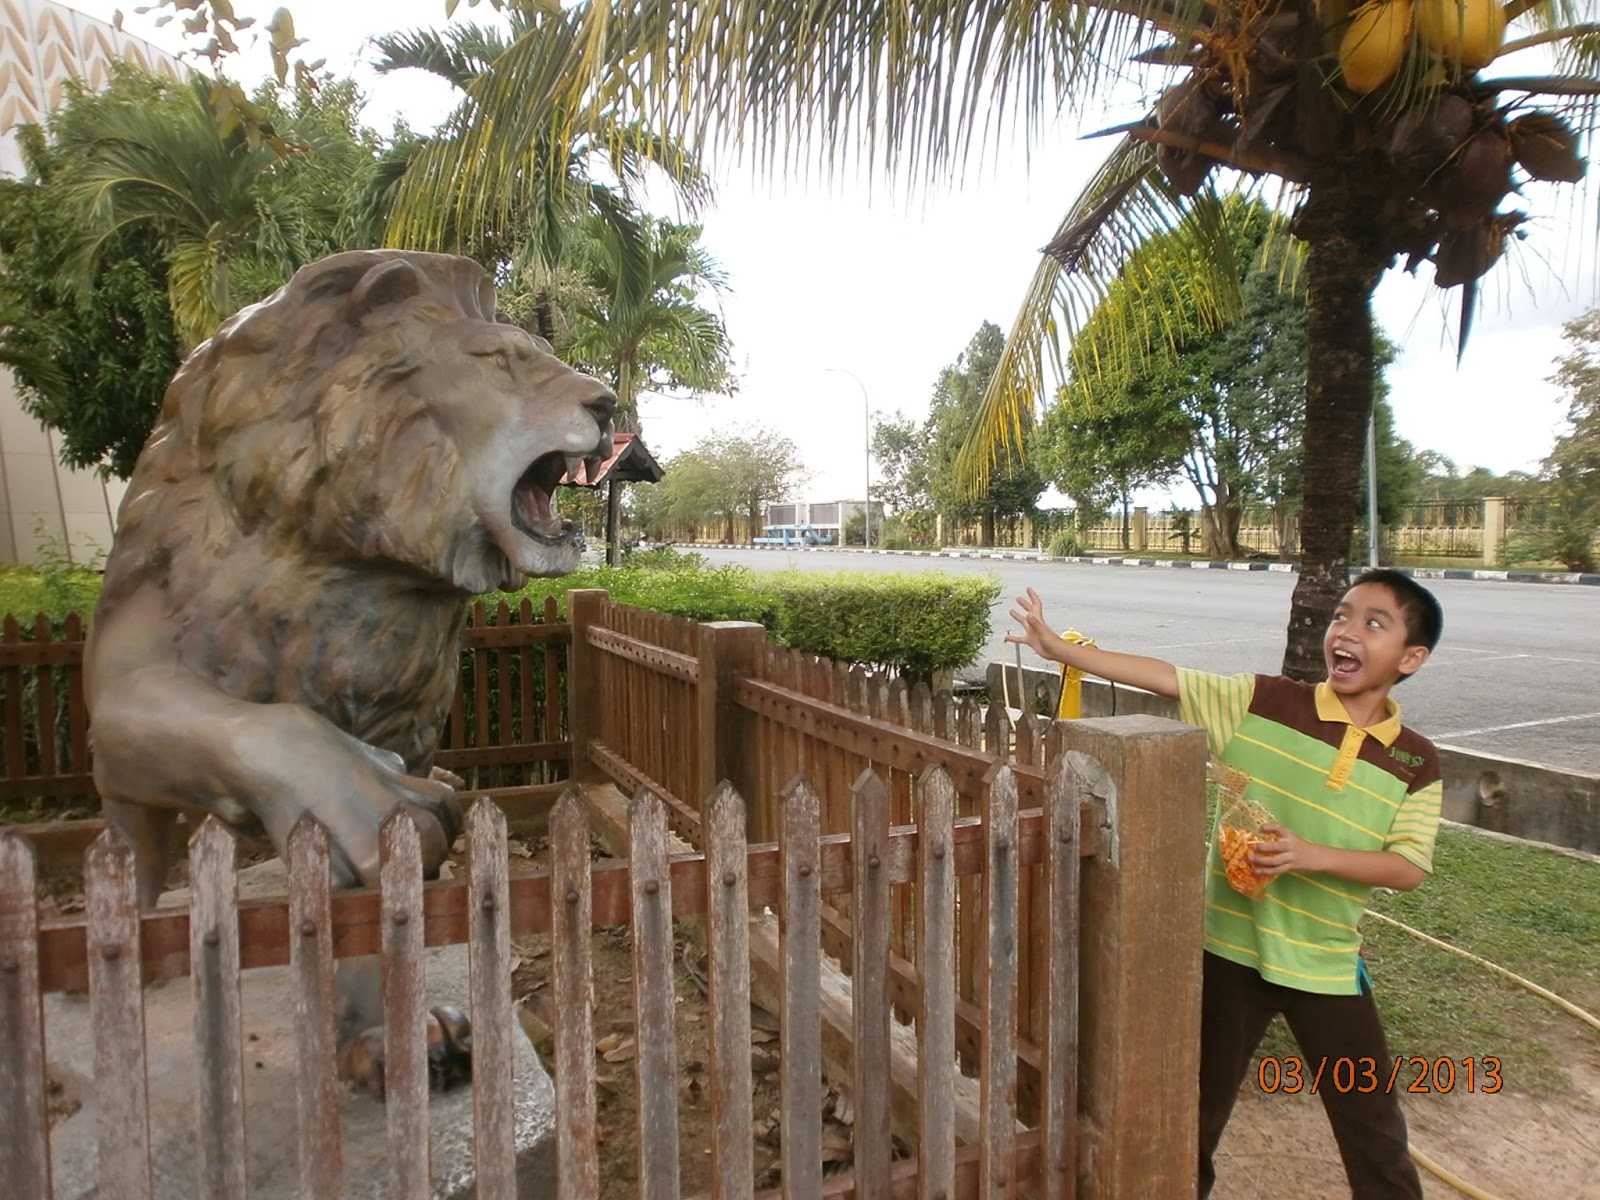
0 832 50 1195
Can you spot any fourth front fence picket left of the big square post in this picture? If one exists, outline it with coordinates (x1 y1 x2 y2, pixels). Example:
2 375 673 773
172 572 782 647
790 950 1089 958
850 770 890 1200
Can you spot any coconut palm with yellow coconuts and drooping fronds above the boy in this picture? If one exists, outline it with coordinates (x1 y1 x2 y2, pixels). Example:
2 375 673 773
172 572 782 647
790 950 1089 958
406 0 1600 678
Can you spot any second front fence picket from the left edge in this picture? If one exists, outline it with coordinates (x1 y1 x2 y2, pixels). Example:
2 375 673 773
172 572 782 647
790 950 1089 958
83 829 150 1200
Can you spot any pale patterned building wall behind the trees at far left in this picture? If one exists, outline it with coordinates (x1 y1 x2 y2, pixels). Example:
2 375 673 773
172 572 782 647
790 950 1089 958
0 0 184 562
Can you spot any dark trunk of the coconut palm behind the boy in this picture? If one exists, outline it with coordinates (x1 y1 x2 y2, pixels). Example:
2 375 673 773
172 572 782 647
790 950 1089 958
1283 181 1386 680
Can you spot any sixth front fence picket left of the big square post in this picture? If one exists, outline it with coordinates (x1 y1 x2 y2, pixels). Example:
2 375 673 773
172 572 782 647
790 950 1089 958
704 782 755 1200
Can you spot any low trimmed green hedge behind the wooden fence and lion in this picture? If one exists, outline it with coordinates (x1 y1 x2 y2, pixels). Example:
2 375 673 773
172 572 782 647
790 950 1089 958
0 550 1000 678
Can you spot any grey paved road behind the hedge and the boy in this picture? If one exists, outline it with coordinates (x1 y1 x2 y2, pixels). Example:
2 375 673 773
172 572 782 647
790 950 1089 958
688 550 1600 774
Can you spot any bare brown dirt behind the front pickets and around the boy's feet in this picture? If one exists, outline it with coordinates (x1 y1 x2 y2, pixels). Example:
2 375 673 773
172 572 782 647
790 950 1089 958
514 838 1600 1200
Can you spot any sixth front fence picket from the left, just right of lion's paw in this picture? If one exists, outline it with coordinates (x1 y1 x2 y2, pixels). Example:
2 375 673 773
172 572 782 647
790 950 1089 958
467 798 517 1197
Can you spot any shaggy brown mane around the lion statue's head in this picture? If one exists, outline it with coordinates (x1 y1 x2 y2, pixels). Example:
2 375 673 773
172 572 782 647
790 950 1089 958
102 251 496 610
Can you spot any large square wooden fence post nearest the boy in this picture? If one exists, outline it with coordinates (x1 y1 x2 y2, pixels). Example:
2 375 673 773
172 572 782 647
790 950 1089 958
1061 715 1206 1200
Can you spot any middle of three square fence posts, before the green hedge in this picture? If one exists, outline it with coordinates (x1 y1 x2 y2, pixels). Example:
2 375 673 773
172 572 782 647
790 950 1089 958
697 621 764 842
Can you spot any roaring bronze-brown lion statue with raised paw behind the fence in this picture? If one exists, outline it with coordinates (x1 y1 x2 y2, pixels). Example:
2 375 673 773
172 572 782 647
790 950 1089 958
85 251 616 1093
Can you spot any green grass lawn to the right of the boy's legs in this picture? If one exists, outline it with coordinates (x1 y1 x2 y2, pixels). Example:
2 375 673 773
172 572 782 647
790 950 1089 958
1262 829 1600 1096
